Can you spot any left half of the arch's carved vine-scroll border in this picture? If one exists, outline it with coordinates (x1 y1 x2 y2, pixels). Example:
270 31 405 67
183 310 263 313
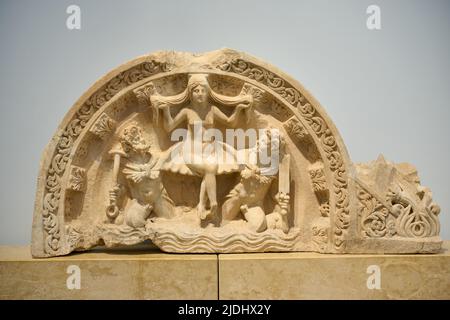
42 61 168 254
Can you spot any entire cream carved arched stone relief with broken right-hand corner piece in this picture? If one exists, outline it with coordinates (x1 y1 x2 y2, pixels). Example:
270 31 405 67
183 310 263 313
32 49 442 257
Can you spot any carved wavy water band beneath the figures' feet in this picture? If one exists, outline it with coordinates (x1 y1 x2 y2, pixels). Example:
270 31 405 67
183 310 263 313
96 221 300 253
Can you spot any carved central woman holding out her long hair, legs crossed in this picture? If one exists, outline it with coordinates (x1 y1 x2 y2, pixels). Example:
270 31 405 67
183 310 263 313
150 74 253 220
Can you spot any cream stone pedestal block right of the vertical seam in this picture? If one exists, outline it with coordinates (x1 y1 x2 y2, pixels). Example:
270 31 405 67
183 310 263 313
219 241 450 300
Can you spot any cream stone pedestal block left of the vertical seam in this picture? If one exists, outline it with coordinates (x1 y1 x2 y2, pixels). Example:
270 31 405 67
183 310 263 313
0 246 218 300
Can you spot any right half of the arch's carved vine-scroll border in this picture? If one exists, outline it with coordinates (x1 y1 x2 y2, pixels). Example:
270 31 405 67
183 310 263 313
217 59 350 250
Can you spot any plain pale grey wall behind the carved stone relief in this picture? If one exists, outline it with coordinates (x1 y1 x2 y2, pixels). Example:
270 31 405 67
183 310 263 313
0 0 450 244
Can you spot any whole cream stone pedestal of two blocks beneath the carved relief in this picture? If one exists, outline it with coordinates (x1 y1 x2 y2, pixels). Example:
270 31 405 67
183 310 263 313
0 241 450 299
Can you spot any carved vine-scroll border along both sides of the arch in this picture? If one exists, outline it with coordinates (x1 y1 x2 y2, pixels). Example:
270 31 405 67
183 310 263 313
42 55 350 253
